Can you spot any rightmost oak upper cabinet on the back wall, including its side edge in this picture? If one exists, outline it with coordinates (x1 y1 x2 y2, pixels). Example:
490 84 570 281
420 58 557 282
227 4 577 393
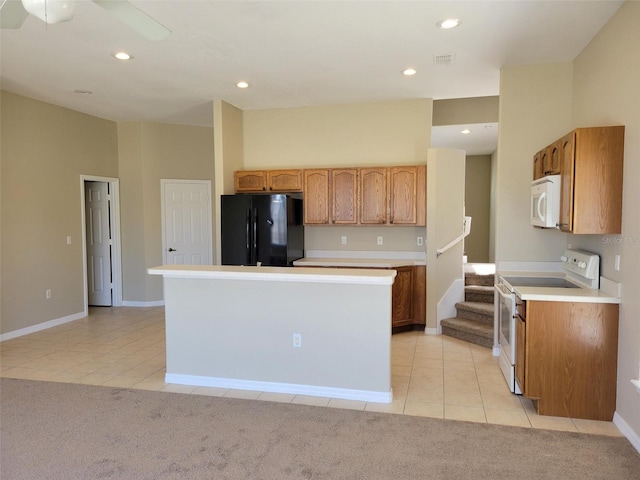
389 165 426 225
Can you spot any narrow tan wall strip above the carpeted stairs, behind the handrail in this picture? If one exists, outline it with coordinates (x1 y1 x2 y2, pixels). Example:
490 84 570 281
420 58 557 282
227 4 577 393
464 155 491 263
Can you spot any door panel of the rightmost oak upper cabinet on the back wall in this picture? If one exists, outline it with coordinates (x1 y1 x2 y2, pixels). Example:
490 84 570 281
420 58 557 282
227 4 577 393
389 166 418 225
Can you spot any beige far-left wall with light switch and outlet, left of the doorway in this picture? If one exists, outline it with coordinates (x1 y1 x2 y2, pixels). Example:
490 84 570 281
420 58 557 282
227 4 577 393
0 92 118 333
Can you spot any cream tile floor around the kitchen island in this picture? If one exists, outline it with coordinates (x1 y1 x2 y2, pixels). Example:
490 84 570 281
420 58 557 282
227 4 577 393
0 307 621 436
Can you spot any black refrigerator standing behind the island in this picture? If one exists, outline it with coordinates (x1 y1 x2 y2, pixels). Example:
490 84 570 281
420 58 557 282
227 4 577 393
221 194 304 267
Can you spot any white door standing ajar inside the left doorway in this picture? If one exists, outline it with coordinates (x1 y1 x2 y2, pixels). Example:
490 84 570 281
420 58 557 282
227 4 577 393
84 182 113 306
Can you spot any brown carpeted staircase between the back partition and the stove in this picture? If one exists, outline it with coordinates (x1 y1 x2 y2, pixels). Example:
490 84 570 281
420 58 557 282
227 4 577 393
440 265 495 348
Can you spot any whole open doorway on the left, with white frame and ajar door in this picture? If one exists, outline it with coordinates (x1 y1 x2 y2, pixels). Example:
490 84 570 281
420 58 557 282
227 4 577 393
80 175 122 313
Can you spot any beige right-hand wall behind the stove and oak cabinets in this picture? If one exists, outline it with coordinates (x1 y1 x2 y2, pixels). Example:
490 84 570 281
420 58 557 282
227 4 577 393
567 2 640 440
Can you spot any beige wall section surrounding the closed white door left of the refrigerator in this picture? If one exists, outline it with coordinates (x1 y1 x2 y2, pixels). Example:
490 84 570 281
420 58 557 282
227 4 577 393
118 122 214 303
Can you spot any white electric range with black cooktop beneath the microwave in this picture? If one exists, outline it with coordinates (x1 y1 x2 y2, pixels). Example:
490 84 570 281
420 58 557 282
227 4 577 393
495 250 600 394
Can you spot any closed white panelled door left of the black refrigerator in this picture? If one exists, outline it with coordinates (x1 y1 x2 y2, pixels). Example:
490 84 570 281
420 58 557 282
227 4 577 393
162 180 212 265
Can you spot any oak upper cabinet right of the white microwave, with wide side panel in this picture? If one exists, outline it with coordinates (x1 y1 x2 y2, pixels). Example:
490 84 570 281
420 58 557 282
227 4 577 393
560 126 624 235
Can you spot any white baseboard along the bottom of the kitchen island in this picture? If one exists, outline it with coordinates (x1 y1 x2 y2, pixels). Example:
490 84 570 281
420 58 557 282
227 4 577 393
164 373 393 403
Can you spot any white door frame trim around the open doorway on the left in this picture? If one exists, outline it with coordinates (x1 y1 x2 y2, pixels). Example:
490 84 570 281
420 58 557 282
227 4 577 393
80 175 122 315
